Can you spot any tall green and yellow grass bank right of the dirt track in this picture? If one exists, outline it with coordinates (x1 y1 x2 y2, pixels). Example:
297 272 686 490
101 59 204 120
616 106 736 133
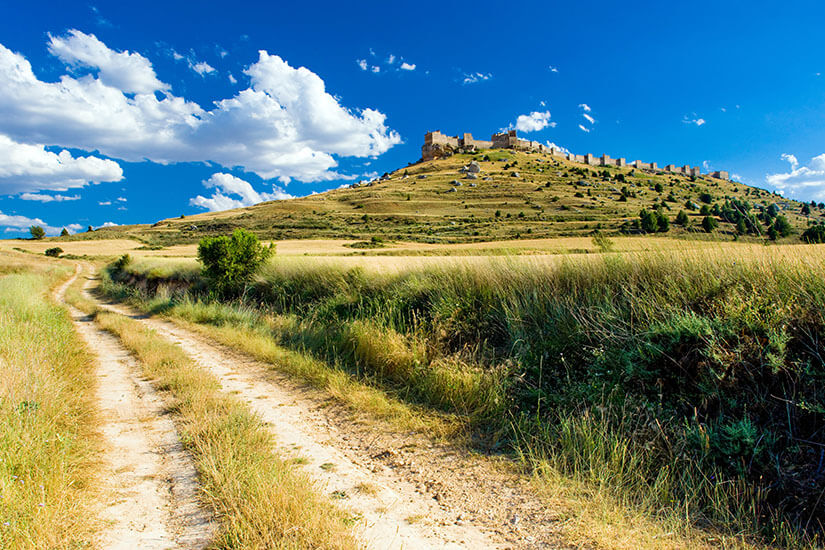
106 246 825 546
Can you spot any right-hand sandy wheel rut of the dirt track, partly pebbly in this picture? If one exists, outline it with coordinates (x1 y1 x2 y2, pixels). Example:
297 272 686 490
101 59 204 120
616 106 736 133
85 274 566 550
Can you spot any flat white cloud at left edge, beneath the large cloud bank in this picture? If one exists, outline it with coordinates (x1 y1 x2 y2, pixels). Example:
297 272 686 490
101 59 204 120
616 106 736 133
0 135 123 195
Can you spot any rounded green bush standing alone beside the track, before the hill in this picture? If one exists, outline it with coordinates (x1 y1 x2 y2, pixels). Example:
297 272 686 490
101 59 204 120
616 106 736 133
198 229 274 294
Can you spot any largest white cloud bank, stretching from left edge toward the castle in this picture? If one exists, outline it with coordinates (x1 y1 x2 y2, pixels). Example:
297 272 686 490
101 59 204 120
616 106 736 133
0 31 401 187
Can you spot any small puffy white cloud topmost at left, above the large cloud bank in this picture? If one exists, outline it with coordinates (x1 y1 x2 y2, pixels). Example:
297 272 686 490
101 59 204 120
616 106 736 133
49 30 169 94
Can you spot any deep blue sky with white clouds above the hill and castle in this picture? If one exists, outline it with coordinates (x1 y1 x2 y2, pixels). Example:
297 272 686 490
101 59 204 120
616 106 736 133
0 1 825 237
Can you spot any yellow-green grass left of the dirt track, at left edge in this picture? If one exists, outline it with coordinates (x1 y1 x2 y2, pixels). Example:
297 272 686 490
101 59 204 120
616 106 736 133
0 255 100 549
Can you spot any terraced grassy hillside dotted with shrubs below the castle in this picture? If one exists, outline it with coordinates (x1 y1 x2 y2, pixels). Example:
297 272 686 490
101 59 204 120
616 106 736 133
56 150 825 245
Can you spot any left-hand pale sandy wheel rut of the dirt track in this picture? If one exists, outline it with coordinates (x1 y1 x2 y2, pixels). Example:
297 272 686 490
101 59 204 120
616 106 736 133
55 272 214 550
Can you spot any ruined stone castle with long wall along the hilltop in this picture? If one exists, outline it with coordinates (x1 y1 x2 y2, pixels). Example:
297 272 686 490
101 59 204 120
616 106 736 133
421 130 730 180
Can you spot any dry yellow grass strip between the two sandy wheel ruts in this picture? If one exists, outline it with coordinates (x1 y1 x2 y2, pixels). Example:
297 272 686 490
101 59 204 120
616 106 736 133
78 306 358 549
